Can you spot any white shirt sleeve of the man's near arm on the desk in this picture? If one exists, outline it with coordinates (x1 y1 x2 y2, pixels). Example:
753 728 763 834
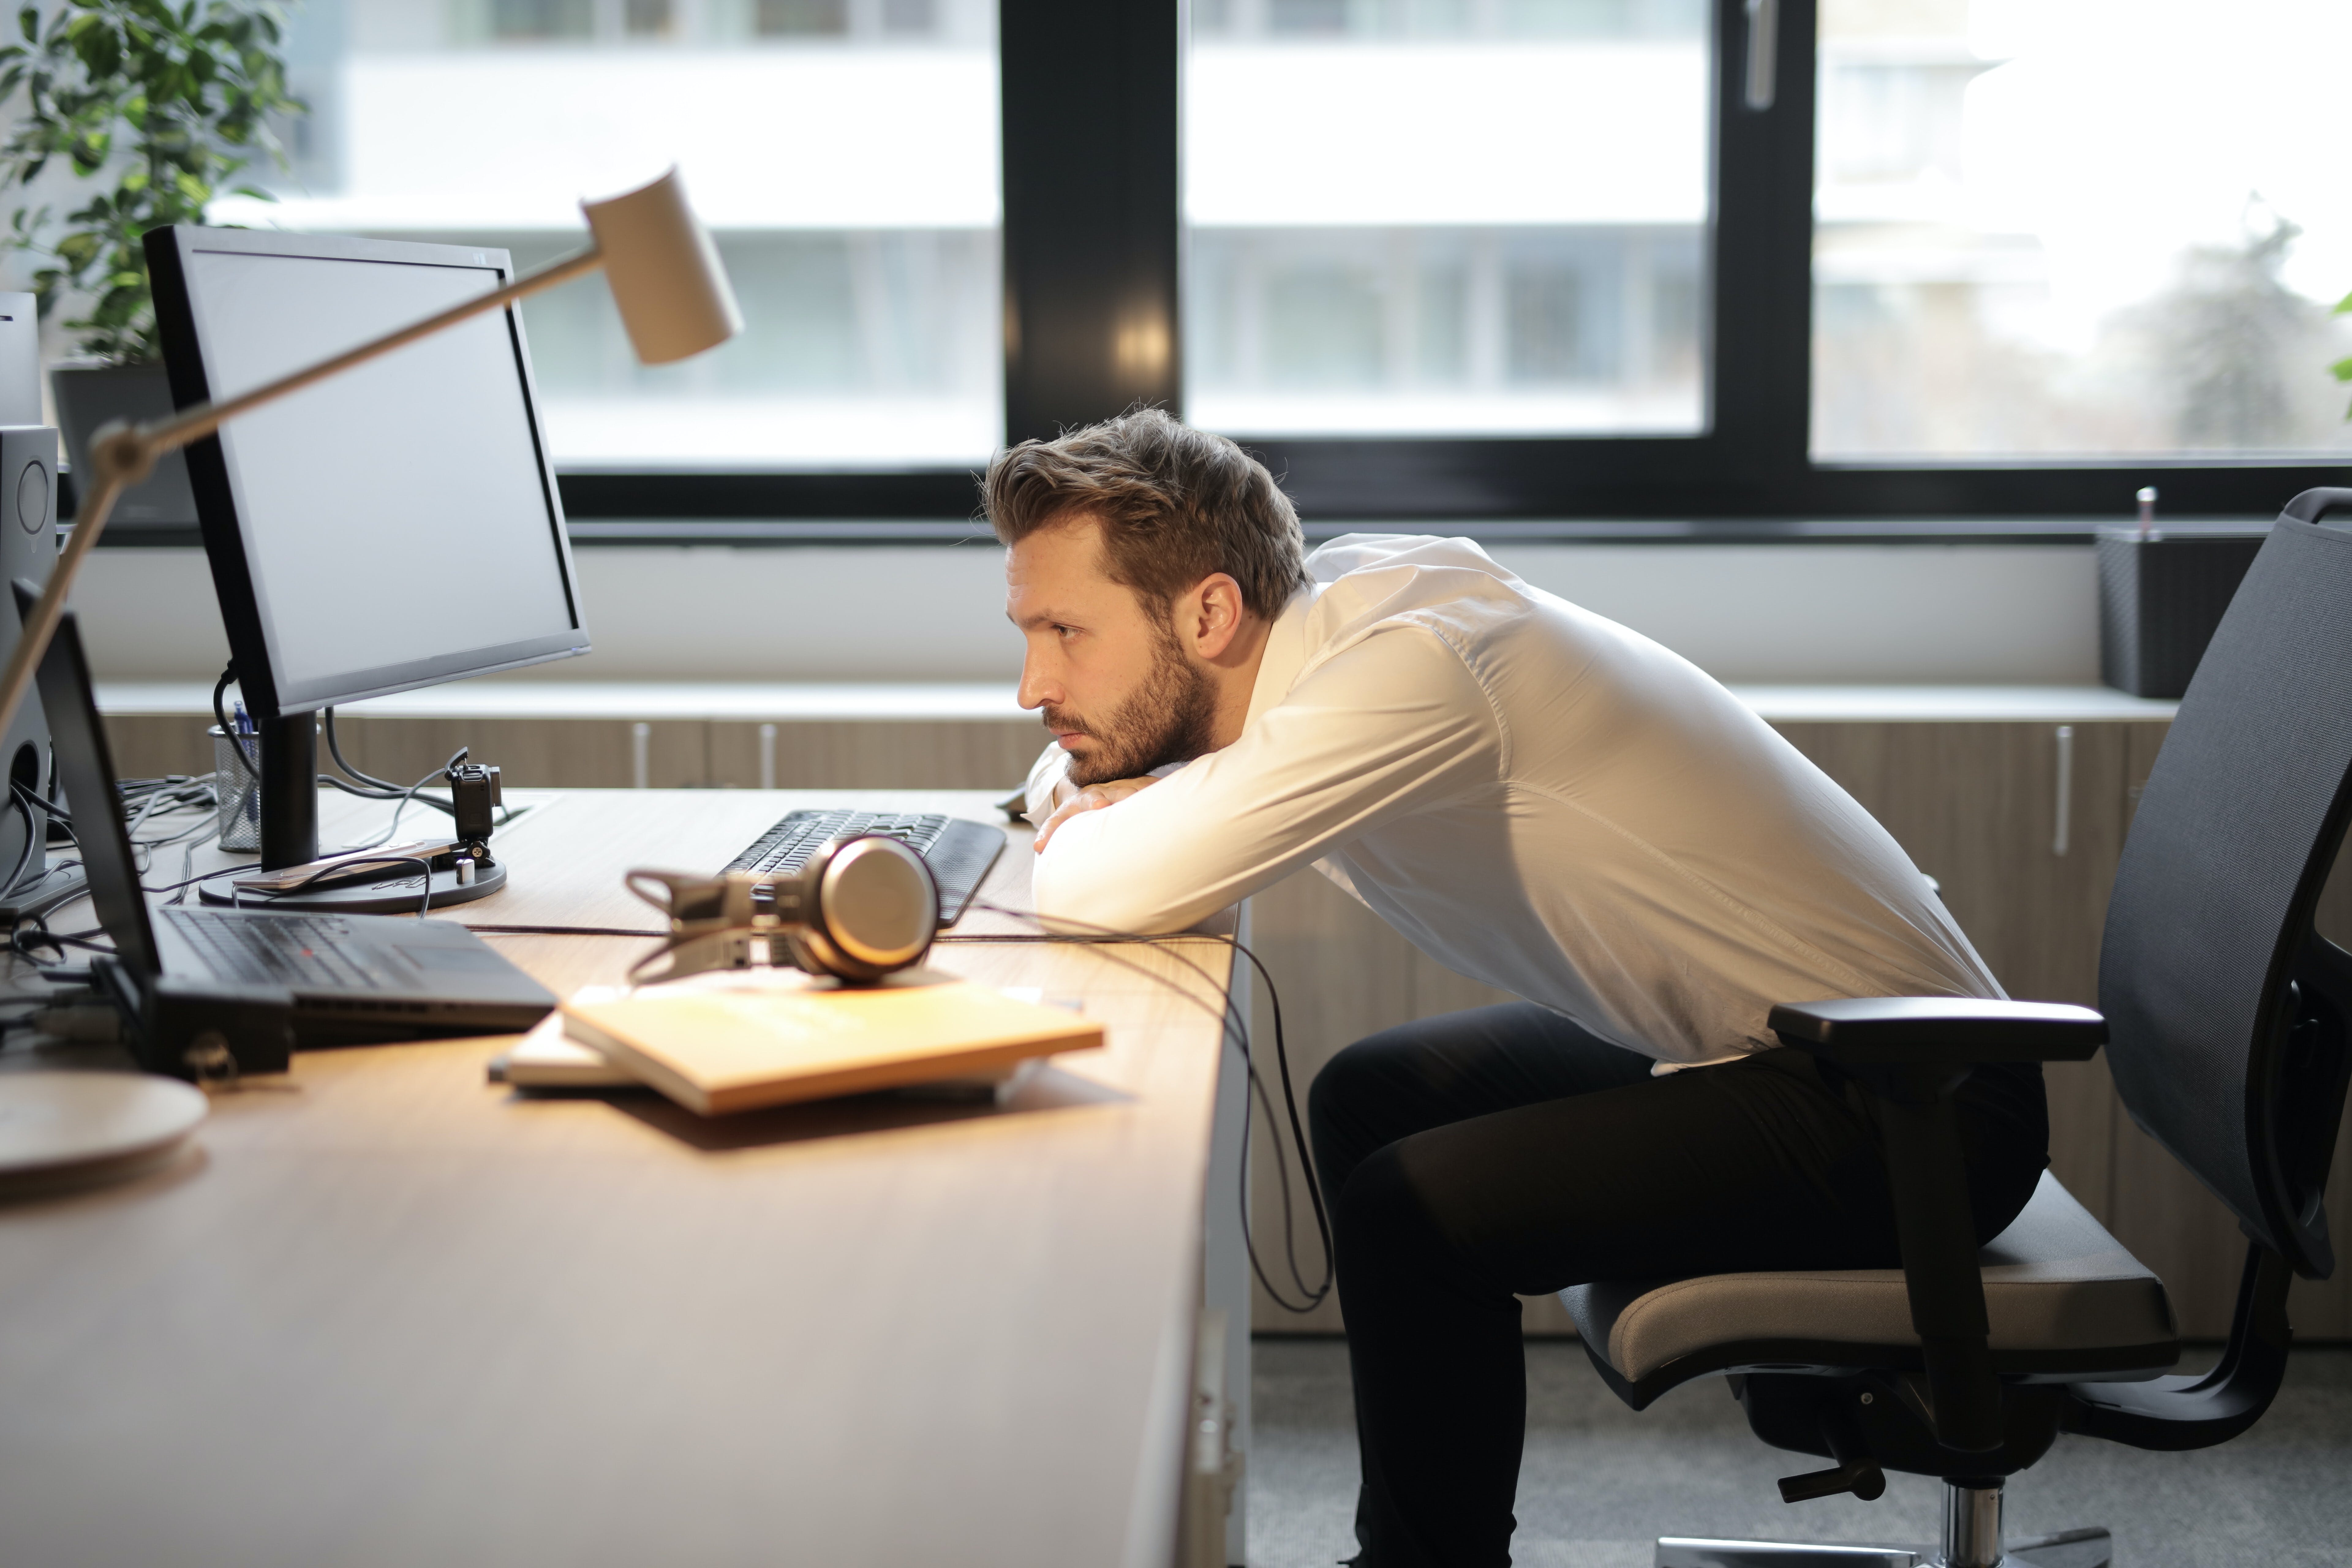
1033 628 1503 933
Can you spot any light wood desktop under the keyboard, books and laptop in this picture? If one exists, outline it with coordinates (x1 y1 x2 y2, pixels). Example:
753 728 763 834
0 792 1230 1568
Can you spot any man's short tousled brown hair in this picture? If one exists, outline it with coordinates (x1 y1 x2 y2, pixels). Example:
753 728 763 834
981 409 1308 621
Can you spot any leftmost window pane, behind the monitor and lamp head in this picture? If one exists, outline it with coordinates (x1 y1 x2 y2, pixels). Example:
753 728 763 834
239 0 1004 470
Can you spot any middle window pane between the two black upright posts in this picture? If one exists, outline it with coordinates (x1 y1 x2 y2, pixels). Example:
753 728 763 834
1183 0 1712 435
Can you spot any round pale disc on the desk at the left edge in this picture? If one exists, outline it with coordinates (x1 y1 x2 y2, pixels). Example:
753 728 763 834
0 1072 209 1189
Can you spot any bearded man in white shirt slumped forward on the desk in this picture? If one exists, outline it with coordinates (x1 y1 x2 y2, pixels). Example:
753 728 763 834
986 411 2046 1568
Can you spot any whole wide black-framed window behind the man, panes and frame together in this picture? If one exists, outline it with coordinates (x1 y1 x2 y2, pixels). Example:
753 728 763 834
41 0 2352 538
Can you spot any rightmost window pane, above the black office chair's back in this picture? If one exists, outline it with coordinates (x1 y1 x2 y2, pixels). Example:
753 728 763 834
1813 0 2352 458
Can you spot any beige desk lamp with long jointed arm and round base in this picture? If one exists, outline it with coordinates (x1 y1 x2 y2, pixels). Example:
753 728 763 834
0 169 743 1192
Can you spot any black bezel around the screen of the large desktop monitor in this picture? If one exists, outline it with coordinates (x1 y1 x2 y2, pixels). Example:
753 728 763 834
146 223 590 717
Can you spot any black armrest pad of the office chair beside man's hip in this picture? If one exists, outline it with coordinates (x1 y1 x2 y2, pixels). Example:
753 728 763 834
1766 997 2107 1067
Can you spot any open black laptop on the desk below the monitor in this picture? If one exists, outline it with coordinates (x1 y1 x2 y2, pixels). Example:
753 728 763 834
32 585 555 1079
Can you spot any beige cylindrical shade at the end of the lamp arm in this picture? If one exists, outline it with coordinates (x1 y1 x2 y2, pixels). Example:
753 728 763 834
581 167 743 364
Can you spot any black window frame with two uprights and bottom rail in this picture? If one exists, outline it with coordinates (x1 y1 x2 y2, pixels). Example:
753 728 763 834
87 0 2352 543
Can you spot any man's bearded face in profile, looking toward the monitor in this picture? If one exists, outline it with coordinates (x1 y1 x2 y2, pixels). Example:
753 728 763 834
1004 519 1216 785
